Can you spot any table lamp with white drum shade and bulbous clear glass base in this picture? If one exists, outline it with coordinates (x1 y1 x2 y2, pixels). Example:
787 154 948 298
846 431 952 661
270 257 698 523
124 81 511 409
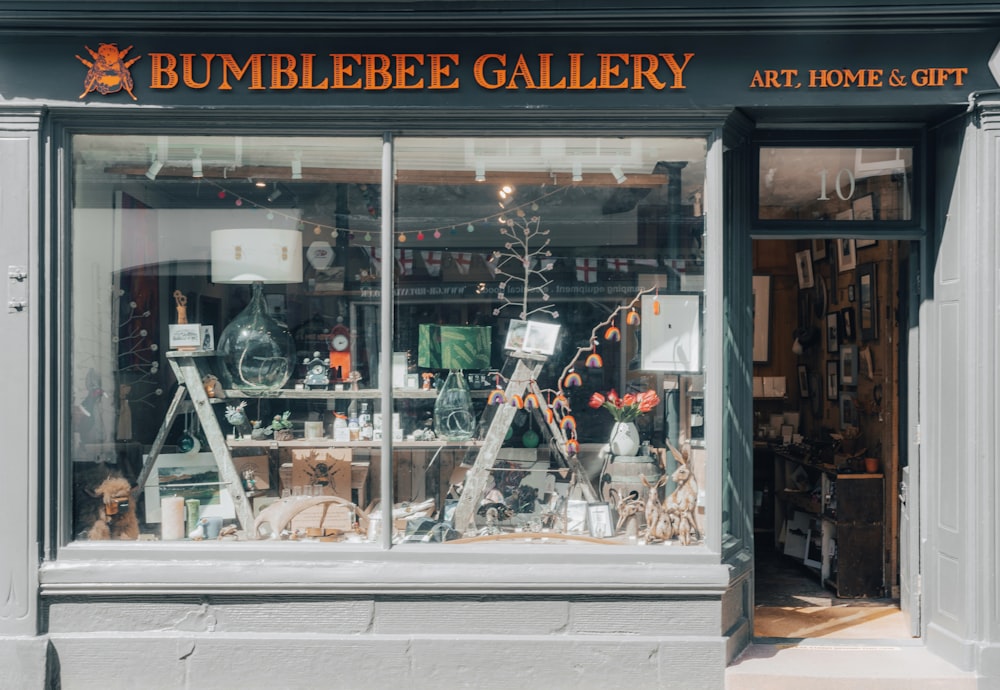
211 228 302 391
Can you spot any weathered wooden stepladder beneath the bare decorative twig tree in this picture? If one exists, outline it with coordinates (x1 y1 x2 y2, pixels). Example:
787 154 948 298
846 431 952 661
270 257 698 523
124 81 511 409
454 353 600 532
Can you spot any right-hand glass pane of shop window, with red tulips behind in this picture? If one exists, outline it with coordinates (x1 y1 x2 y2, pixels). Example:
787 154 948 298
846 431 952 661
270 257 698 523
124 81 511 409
390 138 705 544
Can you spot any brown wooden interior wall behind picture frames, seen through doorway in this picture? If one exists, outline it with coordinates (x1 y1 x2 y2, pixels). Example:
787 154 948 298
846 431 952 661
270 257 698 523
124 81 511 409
754 239 909 585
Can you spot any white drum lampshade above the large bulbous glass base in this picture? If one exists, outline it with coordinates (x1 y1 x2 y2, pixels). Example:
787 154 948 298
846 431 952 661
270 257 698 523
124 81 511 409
212 228 302 283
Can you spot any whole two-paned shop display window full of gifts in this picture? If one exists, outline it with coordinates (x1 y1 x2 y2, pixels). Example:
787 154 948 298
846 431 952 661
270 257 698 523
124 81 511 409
66 135 711 548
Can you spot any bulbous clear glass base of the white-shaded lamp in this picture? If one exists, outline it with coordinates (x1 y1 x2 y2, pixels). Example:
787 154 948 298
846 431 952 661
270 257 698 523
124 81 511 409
216 283 297 391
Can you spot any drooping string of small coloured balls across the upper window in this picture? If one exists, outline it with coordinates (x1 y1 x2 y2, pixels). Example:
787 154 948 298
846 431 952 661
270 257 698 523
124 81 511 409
205 180 570 244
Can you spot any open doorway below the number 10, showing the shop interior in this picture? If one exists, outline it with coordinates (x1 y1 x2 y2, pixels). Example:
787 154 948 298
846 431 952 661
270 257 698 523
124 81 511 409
753 238 911 640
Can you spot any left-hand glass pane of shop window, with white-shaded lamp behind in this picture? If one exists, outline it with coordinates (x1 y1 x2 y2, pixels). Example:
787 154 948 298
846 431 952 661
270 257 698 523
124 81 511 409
67 136 381 541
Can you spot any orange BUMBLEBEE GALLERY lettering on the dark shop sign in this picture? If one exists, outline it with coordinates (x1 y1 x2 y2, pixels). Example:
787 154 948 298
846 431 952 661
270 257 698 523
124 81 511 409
149 53 694 91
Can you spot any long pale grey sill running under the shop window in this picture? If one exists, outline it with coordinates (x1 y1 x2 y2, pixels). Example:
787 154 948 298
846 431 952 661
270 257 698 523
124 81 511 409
39 542 731 596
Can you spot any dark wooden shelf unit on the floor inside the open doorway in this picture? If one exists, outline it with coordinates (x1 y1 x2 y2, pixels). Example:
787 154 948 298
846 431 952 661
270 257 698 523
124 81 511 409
774 447 884 599
